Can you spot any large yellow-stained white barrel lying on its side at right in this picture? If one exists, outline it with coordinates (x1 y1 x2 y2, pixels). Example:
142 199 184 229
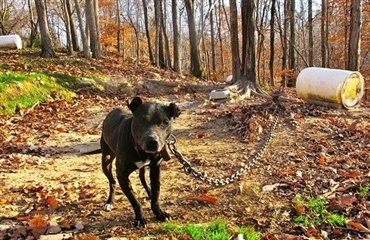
296 67 364 109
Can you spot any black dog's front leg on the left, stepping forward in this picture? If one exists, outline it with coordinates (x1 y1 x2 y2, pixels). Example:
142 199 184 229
117 168 147 227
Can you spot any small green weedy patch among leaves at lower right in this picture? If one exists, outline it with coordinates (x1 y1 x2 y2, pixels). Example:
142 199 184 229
294 196 347 227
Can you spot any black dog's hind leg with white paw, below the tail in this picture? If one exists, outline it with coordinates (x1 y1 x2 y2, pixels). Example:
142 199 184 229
100 138 116 211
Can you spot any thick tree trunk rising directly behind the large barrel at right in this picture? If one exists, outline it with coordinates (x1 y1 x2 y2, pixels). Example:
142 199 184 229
347 0 362 71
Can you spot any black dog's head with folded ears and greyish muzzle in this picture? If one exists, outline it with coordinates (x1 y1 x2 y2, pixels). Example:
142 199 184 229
128 97 180 153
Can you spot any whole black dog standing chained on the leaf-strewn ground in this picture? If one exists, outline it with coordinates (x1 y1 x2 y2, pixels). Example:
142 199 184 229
88 97 180 227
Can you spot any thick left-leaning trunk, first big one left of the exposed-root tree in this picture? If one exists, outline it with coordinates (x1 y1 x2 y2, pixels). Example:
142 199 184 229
184 0 202 77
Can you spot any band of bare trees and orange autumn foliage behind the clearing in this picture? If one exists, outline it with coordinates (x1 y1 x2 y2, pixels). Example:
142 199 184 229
0 0 370 86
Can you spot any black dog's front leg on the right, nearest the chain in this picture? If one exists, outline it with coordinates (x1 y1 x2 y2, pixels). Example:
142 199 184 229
150 164 171 222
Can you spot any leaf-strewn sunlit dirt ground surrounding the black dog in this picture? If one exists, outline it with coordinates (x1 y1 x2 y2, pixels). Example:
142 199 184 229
0 51 370 240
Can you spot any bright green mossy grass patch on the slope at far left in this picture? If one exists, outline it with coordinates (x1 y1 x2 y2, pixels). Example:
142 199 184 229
0 71 76 114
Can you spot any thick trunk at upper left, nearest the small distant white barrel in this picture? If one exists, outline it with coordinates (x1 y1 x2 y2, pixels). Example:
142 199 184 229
35 0 56 58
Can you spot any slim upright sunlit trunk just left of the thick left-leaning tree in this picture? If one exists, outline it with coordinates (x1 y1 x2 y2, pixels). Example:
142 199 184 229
172 0 181 73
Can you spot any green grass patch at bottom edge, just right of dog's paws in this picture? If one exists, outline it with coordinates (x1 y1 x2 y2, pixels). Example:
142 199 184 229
163 220 262 240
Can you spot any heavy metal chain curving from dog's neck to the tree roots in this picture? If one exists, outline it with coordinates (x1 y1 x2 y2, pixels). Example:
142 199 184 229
167 103 284 186
